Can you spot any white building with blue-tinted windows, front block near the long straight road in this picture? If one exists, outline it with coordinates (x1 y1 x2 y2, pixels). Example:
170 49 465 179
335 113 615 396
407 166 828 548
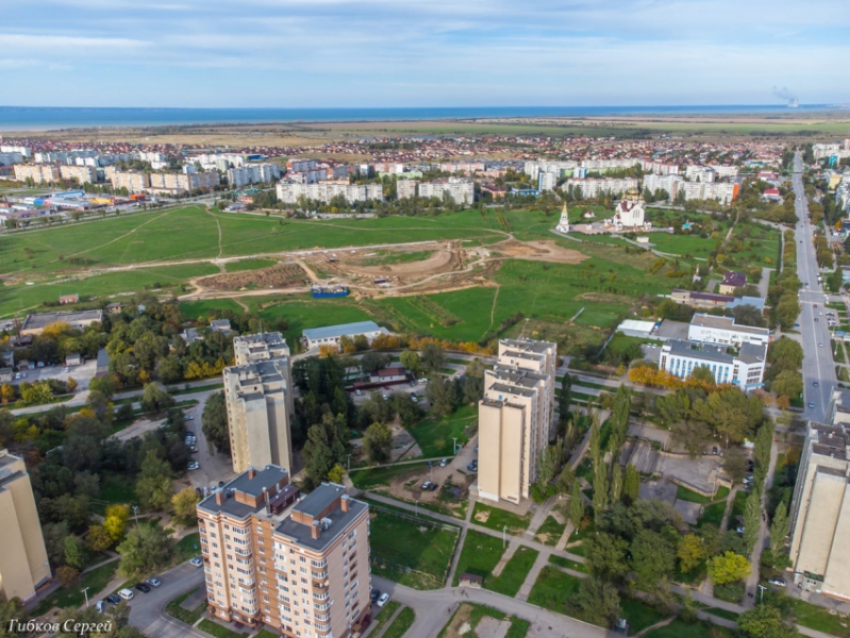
658 339 767 390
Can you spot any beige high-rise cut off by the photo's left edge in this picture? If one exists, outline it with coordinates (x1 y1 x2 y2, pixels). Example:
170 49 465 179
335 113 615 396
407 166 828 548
0 450 50 601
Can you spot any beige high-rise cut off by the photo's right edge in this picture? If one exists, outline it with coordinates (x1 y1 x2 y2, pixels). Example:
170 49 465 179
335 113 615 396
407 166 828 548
790 420 850 601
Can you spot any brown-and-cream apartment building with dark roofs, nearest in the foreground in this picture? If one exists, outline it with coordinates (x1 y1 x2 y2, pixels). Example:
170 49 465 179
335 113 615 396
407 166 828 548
197 472 370 638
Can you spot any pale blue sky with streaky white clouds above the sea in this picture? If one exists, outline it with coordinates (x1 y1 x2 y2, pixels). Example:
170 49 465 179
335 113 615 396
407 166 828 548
0 0 850 107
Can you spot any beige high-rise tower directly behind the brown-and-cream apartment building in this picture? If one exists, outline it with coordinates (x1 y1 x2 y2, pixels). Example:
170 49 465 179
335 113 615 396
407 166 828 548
222 333 294 472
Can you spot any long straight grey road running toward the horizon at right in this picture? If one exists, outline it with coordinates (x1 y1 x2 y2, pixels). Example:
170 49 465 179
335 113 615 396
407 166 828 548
792 153 836 423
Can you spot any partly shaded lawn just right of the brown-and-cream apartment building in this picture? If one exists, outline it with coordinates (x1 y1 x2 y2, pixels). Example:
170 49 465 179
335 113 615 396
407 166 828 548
370 507 460 589
